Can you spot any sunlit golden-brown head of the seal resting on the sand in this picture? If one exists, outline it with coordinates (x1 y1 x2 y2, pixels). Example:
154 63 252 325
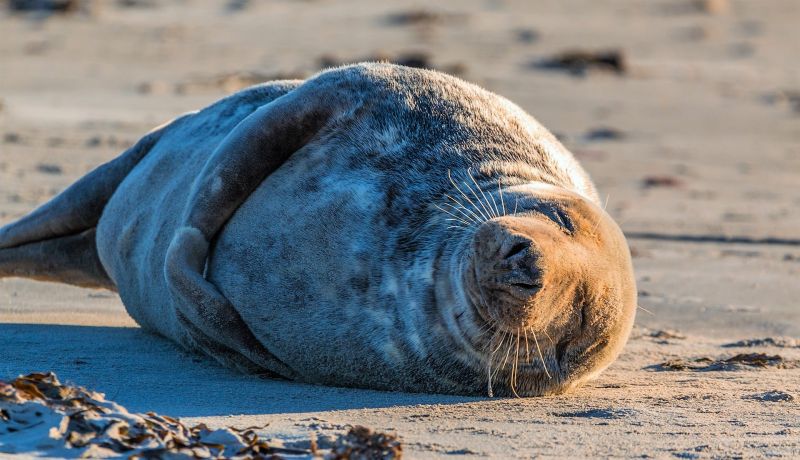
462 181 636 396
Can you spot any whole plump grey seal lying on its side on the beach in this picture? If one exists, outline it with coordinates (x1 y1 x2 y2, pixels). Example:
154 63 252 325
0 63 636 396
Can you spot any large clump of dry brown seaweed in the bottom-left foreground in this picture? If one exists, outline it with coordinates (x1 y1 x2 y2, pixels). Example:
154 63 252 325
0 373 402 459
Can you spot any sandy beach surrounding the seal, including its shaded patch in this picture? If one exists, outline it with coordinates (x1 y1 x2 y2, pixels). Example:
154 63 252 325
0 0 800 458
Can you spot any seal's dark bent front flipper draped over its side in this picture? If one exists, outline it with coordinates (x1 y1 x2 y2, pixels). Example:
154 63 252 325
165 75 358 378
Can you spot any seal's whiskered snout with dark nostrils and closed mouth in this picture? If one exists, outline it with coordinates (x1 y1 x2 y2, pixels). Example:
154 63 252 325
472 218 544 330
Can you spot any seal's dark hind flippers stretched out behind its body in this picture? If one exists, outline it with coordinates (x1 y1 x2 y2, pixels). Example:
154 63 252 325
0 130 161 289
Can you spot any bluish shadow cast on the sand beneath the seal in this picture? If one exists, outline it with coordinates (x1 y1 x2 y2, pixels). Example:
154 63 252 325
0 324 477 417
